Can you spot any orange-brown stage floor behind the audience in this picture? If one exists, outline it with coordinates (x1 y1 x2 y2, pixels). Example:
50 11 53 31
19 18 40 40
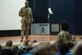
0 35 82 46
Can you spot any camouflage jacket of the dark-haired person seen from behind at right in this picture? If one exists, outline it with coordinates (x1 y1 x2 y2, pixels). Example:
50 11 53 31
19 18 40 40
57 31 72 44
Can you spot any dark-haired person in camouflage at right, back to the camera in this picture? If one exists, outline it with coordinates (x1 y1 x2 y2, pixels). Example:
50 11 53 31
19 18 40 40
57 21 72 44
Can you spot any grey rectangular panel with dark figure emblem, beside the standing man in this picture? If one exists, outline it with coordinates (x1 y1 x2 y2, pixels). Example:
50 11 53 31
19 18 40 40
31 23 50 34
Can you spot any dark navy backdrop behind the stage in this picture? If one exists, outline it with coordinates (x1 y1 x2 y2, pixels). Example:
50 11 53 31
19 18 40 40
29 0 82 35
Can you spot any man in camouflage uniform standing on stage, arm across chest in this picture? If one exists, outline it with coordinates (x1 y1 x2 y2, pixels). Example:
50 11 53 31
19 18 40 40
19 1 33 42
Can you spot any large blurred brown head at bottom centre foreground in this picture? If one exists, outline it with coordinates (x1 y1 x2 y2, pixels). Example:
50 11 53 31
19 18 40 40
33 46 55 55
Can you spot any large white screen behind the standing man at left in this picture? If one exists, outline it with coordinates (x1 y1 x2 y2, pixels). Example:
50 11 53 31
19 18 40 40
0 0 25 31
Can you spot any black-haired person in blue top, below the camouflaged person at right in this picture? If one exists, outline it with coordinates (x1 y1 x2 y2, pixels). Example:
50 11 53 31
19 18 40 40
58 43 73 55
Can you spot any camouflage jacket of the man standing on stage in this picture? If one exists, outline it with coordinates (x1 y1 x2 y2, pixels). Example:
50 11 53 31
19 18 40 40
19 7 33 23
